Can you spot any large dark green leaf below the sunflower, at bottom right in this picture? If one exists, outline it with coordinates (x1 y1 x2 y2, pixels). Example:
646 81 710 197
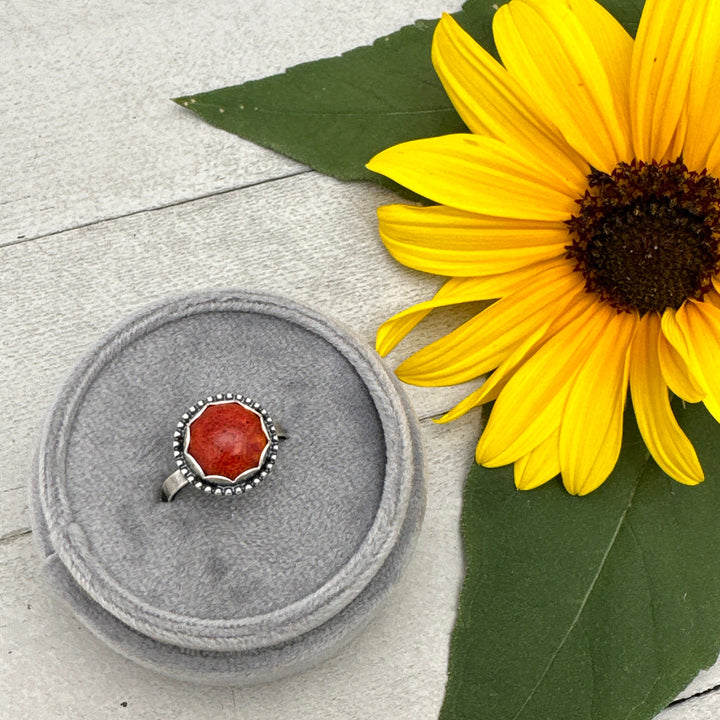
440 405 720 720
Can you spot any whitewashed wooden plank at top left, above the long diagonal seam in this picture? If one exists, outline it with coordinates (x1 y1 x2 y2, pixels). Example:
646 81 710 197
0 0 460 244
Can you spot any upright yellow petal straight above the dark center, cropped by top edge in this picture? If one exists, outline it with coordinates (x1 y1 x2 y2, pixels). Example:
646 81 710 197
630 0 717 162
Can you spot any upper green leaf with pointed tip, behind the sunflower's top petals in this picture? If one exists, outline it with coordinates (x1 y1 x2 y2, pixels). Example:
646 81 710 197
175 0 642 188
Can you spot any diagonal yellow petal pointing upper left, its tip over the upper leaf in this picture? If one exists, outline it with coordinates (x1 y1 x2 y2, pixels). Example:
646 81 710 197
432 14 590 188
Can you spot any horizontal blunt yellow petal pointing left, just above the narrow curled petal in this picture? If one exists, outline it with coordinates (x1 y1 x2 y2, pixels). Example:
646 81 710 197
378 205 569 277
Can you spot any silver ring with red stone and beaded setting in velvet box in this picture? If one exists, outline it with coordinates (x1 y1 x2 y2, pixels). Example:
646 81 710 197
162 393 285 501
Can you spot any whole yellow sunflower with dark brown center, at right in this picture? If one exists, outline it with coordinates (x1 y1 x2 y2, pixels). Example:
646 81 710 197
368 0 720 495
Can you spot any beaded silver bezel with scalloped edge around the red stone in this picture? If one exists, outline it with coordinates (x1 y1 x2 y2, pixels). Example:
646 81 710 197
173 393 279 496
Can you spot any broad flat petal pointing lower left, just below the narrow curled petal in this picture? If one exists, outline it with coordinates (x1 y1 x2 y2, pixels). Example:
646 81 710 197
396 262 582 385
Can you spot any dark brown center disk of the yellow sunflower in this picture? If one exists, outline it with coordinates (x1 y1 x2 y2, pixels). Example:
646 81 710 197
566 159 720 315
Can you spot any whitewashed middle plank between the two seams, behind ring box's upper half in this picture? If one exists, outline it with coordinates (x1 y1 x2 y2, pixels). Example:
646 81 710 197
0 173 480 535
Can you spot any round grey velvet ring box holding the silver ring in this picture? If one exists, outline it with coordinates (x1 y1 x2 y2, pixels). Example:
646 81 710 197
31 291 425 685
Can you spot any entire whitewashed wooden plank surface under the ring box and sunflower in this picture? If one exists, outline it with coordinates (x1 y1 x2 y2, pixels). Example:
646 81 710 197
0 0 720 720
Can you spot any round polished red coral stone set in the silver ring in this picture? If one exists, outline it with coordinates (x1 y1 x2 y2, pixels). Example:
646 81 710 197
187 400 269 481
